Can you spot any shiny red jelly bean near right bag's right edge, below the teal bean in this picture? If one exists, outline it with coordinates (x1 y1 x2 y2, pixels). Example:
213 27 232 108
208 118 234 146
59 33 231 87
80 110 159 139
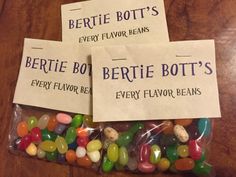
188 140 202 160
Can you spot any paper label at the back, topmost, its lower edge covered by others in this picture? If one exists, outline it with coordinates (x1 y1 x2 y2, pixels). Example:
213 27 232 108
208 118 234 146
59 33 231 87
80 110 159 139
61 0 169 46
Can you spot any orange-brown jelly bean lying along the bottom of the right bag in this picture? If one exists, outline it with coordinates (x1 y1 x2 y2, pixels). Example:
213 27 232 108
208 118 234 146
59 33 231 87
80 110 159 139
175 158 195 171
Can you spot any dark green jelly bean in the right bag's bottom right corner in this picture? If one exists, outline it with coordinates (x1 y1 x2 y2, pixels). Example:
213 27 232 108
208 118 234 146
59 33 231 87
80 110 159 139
193 162 212 176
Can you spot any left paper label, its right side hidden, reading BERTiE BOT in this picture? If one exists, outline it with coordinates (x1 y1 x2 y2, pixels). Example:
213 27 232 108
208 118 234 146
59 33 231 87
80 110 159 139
13 39 92 114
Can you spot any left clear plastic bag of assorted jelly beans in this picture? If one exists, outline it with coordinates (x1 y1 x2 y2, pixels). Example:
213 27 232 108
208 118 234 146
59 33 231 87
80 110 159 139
9 105 102 170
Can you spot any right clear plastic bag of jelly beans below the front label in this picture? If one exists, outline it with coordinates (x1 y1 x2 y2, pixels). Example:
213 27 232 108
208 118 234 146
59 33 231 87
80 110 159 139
101 118 215 177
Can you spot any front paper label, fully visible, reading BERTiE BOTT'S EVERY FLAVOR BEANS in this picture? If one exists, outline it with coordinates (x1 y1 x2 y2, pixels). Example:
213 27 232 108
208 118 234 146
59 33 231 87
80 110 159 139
92 40 221 121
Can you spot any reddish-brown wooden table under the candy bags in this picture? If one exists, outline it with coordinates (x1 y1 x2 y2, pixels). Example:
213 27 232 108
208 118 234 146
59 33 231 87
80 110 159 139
0 0 236 177
